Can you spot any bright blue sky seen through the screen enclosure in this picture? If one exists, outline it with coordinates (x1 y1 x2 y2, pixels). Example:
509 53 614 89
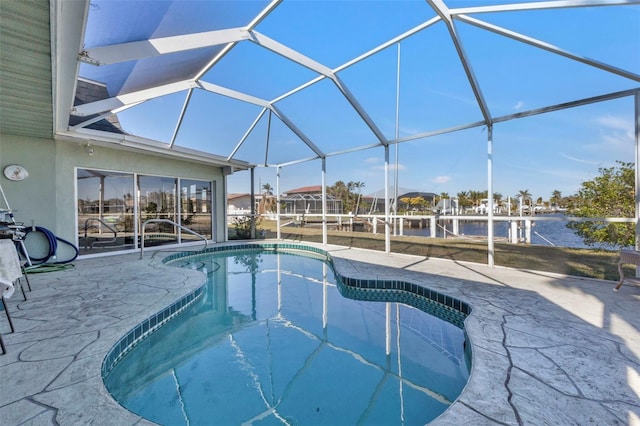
81 0 640 199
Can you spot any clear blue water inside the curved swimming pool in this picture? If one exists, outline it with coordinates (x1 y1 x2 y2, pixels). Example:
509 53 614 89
105 251 469 425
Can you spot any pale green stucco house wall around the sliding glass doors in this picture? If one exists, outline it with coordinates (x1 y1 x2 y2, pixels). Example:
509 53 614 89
0 134 226 250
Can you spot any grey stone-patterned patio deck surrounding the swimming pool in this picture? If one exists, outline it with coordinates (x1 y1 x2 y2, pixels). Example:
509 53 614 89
0 244 640 426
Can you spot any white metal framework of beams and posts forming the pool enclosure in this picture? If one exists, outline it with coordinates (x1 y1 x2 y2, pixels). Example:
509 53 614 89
58 0 640 273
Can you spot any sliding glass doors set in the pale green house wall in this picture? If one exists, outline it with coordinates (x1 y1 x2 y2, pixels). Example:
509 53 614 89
77 169 215 255
